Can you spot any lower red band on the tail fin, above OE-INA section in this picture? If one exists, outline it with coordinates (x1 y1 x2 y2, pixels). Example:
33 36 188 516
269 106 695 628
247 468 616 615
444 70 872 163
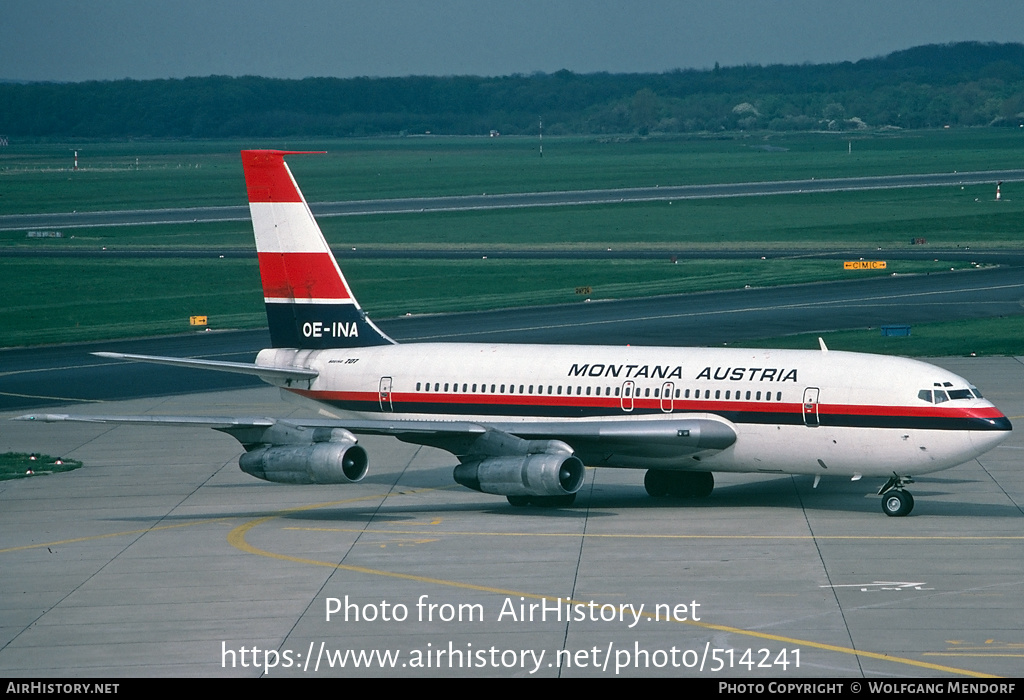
259 253 351 299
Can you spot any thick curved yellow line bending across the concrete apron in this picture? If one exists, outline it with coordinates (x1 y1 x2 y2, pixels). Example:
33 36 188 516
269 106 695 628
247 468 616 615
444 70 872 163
227 489 998 679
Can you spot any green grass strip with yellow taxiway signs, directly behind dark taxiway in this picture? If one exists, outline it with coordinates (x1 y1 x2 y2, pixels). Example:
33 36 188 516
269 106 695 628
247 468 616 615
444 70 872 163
0 256 983 347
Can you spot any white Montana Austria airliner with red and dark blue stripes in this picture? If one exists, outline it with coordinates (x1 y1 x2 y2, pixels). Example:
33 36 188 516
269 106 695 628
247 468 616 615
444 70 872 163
22 150 1012 516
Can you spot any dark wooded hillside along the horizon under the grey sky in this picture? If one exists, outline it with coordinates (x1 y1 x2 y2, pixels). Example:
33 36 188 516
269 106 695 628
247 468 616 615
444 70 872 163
0 43 1024 138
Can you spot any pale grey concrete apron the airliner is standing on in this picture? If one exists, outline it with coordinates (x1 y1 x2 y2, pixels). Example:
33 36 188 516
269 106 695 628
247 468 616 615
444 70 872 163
0 358 1024 681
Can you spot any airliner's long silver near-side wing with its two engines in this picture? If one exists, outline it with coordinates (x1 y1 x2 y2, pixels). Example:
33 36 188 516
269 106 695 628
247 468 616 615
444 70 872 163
14 413 736 495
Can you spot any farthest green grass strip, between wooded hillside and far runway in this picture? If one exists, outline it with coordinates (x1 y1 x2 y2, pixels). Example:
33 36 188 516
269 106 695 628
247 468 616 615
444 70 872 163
6 129 1024 214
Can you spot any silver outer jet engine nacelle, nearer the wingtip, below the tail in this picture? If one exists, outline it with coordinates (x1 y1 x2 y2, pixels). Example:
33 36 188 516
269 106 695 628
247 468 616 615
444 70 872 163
239 442 369 484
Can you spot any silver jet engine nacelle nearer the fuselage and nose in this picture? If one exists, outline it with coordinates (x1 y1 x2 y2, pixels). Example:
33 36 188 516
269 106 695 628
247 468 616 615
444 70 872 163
454 453 585 496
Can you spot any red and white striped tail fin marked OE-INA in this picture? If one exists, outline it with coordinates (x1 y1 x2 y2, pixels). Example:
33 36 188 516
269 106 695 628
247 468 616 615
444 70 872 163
242 150 394 349
